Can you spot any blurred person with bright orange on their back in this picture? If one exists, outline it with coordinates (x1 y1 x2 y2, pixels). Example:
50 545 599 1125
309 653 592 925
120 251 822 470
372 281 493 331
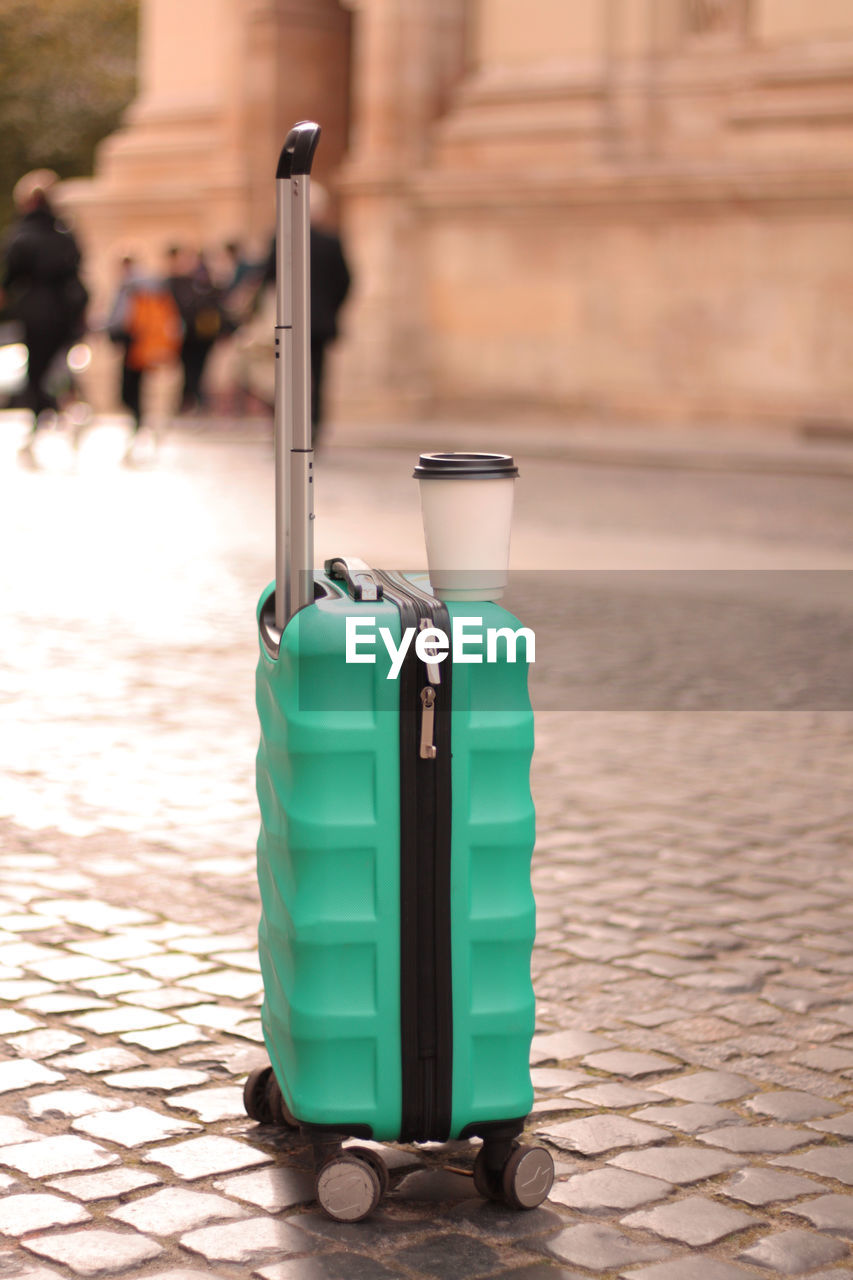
106 255 183 461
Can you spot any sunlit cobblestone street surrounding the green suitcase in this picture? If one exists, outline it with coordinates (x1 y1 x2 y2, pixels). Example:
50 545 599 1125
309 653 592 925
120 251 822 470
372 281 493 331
0 415 853 1280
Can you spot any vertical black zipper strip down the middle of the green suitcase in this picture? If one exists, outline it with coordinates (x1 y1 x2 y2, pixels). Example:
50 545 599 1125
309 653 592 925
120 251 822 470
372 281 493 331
379 571 453 1142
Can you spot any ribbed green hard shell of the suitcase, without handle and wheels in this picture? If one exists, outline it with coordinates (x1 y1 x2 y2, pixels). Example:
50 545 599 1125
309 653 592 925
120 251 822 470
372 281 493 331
256 579 535 1140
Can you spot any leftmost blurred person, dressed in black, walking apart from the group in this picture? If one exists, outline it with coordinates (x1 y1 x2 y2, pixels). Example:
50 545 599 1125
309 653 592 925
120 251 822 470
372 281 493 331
1 169 88 461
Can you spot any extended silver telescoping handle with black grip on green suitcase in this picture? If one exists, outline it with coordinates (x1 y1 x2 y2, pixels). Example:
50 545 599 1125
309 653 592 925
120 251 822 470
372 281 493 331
274 120 320 631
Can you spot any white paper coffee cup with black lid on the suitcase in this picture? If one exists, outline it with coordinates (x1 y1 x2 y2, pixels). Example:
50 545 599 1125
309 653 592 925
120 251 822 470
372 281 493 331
414 453 519 600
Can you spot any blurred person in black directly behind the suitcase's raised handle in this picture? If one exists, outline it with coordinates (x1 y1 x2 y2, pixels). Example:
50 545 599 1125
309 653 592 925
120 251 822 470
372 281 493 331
264 182 351 447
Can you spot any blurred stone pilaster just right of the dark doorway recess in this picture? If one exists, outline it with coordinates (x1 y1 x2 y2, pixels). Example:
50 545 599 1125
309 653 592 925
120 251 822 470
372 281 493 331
336 0 465 419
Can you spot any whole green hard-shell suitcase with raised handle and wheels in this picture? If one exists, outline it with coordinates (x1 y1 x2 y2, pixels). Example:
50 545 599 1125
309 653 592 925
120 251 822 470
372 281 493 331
245 123 553 1221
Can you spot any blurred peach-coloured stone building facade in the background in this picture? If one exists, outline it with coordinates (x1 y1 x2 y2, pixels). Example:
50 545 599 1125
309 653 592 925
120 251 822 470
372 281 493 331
68 0 853 422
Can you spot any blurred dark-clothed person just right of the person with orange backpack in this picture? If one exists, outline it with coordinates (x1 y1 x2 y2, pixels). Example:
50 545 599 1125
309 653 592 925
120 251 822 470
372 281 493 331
168 248 225 413
